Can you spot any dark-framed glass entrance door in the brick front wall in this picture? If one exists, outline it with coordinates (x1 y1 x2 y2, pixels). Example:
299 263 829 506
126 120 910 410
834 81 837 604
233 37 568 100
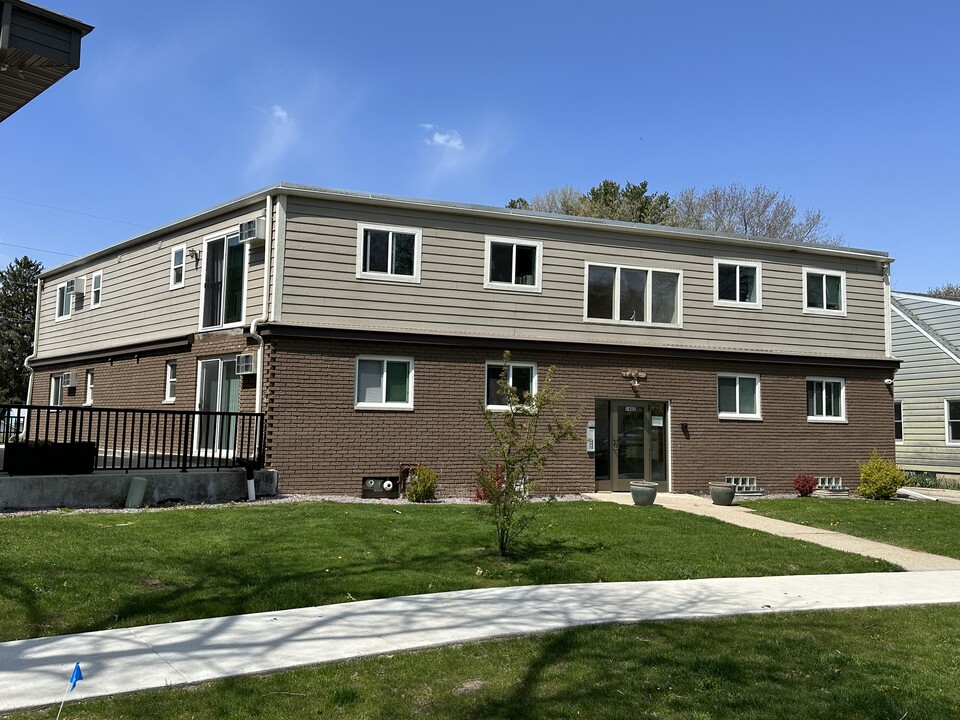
596 400 669 491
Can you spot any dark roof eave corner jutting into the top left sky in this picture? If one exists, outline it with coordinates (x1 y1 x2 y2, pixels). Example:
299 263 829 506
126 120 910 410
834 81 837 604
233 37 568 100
0 0 93 122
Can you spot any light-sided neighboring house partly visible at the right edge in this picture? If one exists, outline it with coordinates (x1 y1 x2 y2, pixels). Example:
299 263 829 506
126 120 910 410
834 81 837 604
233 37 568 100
891 292 960 474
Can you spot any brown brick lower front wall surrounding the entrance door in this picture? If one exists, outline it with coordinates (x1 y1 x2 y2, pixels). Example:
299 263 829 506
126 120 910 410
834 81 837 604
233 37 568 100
266 337 894 495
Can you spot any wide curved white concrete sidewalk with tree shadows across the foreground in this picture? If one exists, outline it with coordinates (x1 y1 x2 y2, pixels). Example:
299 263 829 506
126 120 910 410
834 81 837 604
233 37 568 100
0 571 960 712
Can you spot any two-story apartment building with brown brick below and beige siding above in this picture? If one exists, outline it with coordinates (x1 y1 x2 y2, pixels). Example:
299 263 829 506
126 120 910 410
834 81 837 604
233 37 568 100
30 184 897 494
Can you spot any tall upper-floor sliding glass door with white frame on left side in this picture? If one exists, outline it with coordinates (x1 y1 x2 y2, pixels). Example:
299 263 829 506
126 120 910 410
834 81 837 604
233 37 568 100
200 233 246 330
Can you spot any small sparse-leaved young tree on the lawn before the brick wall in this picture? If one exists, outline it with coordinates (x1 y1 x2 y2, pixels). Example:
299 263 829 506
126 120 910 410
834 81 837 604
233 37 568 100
476 352 580 557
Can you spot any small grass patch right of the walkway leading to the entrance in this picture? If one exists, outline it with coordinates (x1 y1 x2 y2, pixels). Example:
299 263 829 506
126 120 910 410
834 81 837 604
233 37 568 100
742 498 960 559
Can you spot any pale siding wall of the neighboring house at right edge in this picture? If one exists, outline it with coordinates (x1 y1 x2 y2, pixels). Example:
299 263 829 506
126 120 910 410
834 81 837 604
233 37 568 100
892 307 960 473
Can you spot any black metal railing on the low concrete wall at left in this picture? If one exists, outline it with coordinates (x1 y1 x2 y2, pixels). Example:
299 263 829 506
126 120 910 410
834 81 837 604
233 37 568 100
0 405 264 472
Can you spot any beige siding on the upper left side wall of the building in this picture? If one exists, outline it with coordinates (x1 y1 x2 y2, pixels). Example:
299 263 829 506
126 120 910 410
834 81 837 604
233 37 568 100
37 205 264 359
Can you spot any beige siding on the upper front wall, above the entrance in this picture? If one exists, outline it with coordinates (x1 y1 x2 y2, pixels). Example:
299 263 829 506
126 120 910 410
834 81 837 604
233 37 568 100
276 197 886 357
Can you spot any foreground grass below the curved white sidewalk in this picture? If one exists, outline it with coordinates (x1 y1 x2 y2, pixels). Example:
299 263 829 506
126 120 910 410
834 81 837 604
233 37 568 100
13 606 960 720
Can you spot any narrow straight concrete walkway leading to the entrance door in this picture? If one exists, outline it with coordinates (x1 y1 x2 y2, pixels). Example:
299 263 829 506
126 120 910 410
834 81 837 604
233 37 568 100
584 492 960 572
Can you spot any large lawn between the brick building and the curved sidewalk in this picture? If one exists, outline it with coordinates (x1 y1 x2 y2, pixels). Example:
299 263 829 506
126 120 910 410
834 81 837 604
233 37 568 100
0 502 897 640
